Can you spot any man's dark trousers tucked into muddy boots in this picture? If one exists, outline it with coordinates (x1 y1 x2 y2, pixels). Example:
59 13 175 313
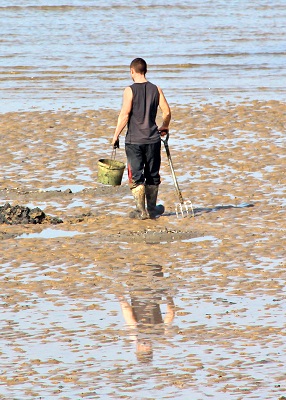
125 141 161 189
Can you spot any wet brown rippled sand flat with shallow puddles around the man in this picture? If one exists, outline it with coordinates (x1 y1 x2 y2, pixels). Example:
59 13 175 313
0 101 286 399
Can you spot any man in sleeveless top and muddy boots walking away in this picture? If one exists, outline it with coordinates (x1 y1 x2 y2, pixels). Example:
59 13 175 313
112 58 171 219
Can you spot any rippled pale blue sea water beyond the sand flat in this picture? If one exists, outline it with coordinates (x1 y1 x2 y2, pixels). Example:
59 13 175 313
0 0 286 112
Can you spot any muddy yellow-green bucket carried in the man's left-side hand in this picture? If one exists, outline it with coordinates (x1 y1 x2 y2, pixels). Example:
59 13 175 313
97 159 125 186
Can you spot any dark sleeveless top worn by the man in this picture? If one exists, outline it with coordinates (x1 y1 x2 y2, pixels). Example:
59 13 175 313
125 82 161 144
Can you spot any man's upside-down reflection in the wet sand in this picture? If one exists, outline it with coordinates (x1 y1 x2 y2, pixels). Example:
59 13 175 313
119 264 175 362
